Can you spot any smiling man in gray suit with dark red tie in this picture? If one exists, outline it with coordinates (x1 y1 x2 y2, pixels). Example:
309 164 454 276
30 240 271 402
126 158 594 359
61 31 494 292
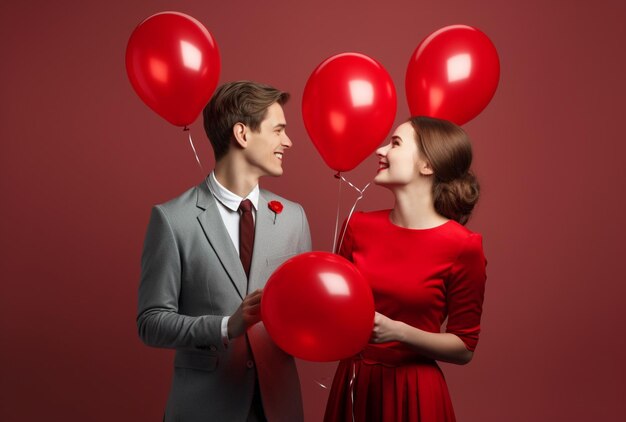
137 81 311 422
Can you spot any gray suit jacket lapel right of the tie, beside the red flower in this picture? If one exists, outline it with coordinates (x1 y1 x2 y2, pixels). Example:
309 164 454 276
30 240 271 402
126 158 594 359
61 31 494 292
248 192 274 293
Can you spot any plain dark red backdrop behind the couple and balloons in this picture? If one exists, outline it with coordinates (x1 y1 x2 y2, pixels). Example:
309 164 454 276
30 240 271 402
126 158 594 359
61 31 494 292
0 0 626 422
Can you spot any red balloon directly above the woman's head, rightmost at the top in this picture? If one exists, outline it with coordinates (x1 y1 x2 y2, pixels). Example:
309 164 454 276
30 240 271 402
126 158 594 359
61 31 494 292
405 25 500 125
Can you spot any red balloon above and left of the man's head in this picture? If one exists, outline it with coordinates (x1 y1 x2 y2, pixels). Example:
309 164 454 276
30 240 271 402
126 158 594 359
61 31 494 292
126 12 221 126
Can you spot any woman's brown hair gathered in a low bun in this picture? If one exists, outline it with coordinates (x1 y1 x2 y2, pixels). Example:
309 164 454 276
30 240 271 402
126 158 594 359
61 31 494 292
409 116 480 224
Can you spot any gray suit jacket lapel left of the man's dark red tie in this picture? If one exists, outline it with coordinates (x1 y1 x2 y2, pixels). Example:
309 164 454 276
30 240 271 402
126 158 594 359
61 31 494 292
196 182 246 299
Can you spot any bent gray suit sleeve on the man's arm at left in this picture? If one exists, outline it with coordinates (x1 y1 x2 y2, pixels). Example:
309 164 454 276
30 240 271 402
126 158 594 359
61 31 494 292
137 206 224 350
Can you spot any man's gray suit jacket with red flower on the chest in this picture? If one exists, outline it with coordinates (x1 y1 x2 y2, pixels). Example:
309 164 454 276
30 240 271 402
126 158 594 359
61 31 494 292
137 182 311 422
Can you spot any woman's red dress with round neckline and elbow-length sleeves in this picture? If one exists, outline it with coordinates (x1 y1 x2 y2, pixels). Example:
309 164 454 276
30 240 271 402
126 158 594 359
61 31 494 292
324 210 486 422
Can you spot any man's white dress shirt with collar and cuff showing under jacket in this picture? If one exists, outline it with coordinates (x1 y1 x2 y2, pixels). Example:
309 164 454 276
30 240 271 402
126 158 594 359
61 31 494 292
206 171 259 346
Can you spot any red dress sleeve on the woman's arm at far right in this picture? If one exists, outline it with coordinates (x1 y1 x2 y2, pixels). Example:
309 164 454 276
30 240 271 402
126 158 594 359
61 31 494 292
446 233 487 352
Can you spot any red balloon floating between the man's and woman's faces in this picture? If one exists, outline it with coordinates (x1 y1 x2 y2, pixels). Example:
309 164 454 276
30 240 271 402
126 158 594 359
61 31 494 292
302 53 396 171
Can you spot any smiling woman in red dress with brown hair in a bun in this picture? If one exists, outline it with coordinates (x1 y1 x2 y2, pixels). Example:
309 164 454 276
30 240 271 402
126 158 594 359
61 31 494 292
325 117 486 422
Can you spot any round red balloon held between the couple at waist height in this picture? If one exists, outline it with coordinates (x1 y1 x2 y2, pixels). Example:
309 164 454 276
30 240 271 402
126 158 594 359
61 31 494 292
261 252 374 362
